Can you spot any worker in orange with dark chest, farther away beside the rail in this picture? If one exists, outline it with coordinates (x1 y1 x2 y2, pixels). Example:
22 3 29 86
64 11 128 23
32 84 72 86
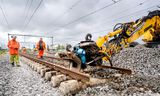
37 38 46 59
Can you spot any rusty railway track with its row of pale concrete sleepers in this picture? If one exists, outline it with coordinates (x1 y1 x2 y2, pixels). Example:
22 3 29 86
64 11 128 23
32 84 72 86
20 53 130 95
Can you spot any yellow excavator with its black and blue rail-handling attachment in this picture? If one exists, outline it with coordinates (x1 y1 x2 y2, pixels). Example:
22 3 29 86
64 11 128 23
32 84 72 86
60 10 160 71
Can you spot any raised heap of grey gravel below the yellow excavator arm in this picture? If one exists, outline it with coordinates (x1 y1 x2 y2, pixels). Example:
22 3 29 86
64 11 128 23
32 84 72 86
112 48 160 76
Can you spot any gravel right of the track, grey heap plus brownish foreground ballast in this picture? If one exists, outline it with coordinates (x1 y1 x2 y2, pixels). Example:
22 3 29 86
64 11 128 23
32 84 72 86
76 47 160 96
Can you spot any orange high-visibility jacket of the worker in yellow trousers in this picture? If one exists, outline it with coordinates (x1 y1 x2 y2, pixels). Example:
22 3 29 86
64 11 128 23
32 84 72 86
8 40 20 55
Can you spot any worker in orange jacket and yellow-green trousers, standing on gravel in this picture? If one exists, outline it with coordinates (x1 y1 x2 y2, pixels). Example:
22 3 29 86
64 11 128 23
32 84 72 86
8 36 20 67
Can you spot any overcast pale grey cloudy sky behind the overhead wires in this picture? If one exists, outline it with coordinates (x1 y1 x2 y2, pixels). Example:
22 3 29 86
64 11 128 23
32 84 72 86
0 0 160 46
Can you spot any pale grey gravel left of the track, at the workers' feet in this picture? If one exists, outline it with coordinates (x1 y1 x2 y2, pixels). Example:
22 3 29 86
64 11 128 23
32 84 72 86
0 55 62 96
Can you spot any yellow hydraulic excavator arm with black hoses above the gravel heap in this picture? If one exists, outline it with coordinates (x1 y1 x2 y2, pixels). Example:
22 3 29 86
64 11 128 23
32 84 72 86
96 10 160 61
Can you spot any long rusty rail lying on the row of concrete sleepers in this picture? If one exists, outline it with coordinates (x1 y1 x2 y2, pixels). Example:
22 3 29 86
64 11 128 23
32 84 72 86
20 53 90 82
